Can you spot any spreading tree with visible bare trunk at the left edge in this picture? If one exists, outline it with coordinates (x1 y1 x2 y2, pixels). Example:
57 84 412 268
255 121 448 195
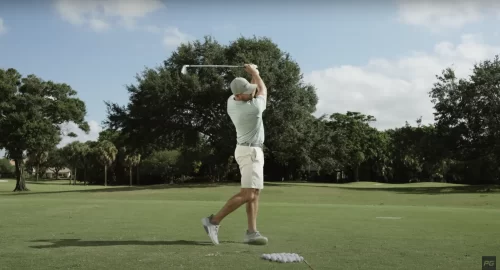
0 68 89 191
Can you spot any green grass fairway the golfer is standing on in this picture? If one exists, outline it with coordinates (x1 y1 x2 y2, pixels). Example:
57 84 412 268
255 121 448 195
0 181 500 270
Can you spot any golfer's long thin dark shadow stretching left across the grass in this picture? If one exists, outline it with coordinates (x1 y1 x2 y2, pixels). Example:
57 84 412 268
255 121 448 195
30 239 236 249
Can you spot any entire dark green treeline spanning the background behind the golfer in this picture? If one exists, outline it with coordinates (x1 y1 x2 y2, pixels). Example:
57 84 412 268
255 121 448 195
0 37 500 192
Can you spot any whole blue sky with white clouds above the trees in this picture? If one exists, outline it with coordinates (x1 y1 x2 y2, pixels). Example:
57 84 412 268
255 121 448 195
0 0 500 154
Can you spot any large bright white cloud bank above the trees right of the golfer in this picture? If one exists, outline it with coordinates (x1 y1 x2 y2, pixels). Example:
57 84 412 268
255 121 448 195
305 35 500 129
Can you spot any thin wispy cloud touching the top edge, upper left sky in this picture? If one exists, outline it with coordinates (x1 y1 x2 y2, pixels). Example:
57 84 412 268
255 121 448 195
55 0 165 31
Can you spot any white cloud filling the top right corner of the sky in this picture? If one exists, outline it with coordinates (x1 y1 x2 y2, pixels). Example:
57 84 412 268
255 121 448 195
399 0 500 31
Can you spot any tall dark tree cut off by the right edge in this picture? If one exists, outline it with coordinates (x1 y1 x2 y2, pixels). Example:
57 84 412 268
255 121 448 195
429 55 500 183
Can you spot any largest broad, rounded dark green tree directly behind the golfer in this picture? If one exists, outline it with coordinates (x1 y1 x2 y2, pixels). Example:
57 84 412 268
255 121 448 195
106 34 317 180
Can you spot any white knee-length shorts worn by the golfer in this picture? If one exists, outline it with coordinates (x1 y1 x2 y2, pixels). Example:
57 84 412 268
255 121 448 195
234 145 264 189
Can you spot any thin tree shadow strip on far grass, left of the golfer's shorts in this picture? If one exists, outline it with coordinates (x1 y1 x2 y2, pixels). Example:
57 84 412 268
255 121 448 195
4 183 237 196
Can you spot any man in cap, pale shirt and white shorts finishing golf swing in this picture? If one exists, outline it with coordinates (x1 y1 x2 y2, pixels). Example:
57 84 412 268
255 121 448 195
201 64 267 245
